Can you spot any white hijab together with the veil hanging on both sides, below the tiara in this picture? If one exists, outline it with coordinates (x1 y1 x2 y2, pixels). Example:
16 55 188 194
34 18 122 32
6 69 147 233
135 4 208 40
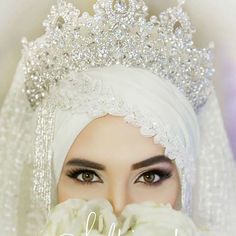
0 61 236 236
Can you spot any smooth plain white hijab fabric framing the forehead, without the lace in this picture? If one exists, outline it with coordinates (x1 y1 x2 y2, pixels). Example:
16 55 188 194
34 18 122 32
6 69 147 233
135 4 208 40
53 65 199 186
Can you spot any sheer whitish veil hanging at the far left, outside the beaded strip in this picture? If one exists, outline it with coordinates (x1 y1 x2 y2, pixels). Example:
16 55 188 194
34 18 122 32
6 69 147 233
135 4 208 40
0 60 34 235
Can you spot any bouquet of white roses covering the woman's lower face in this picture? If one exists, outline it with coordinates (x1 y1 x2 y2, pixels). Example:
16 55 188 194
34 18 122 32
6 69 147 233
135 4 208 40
41 198 220 236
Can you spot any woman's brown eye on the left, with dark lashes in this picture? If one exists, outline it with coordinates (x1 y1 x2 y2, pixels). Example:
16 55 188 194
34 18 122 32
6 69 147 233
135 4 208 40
67 169 102 184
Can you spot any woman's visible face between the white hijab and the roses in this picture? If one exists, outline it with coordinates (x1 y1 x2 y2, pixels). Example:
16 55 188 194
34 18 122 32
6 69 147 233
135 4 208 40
57 115 180 214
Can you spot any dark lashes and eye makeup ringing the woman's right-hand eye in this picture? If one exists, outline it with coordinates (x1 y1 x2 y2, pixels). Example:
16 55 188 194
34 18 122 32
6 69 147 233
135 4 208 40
135 169 172 187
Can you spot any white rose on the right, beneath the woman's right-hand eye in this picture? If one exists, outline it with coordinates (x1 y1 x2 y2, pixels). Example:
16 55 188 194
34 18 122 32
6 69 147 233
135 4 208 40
119 201 198 236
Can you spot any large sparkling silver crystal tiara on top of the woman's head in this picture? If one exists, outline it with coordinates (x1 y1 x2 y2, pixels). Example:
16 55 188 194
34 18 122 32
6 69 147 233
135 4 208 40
22 0 214 111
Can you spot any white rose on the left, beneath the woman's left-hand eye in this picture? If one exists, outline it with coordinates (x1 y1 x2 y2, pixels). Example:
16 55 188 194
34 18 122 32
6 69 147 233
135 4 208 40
41 199 117 236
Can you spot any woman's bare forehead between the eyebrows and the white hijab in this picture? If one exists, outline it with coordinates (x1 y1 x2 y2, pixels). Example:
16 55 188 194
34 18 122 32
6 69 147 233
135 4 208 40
65 114 164 165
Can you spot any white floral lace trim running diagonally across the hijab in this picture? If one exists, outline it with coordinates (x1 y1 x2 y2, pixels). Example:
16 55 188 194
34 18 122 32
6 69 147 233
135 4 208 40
48 72 195 206
